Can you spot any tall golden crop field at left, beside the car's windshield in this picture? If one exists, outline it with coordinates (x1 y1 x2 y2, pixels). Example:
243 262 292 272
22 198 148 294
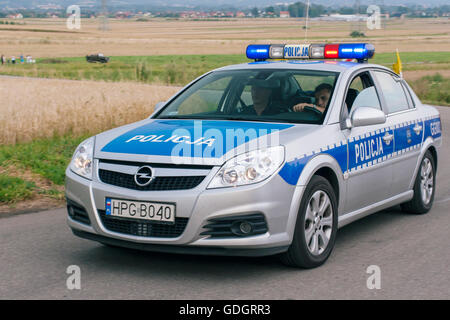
0 77 179 145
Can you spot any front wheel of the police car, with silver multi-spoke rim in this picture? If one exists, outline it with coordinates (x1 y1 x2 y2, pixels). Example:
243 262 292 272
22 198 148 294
280 176 338 269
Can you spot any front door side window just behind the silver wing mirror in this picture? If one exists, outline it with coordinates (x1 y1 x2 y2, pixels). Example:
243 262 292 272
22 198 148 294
345 73 381 114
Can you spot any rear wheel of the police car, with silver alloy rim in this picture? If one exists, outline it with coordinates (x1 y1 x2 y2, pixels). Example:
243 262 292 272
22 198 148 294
401 150 436 214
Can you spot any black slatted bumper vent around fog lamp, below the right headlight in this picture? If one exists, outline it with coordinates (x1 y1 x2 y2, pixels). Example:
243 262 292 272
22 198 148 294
200 213 268 238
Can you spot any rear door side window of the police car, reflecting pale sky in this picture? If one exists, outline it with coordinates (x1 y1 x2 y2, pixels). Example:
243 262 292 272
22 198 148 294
374 71 409 113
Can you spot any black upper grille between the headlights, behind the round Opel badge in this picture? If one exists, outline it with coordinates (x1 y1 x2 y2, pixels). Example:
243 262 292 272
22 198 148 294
98 169 205 191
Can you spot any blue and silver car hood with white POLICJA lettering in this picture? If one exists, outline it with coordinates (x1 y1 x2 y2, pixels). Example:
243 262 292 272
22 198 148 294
94 119 320 165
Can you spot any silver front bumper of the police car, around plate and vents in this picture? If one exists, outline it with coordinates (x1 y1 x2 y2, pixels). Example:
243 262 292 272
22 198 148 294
66 164 303 256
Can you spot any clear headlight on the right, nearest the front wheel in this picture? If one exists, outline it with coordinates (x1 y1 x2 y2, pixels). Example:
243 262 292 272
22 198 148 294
208 146 284 189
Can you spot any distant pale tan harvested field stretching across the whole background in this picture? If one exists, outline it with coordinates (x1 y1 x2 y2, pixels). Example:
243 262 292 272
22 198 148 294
0 18 450 58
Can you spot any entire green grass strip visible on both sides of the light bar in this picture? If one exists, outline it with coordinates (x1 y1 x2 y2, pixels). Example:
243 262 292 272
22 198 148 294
0 52 450 85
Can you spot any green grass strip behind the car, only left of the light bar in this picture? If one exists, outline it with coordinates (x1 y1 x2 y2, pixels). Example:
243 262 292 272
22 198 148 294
0 55 248 85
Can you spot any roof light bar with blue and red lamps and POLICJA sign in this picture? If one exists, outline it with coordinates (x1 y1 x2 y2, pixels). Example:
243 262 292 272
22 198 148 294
246 43 375 62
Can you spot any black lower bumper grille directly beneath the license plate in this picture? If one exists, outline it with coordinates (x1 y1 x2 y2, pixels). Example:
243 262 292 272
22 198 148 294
98 210 189 238
